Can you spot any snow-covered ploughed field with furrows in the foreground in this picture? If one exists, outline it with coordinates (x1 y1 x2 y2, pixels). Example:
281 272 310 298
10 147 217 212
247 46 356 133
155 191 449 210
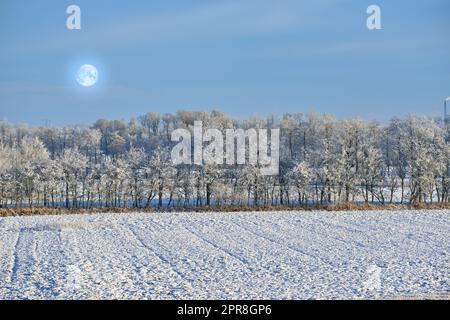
0 210 450 299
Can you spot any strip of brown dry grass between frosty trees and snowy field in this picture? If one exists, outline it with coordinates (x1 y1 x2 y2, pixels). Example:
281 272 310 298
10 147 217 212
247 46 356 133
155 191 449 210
0 203 450 217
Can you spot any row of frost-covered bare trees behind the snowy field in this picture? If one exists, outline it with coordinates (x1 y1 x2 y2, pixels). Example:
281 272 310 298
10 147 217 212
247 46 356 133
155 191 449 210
0 111 450 208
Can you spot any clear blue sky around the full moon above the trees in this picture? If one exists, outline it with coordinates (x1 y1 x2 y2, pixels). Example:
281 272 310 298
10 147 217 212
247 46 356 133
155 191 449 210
0 0 450 125
